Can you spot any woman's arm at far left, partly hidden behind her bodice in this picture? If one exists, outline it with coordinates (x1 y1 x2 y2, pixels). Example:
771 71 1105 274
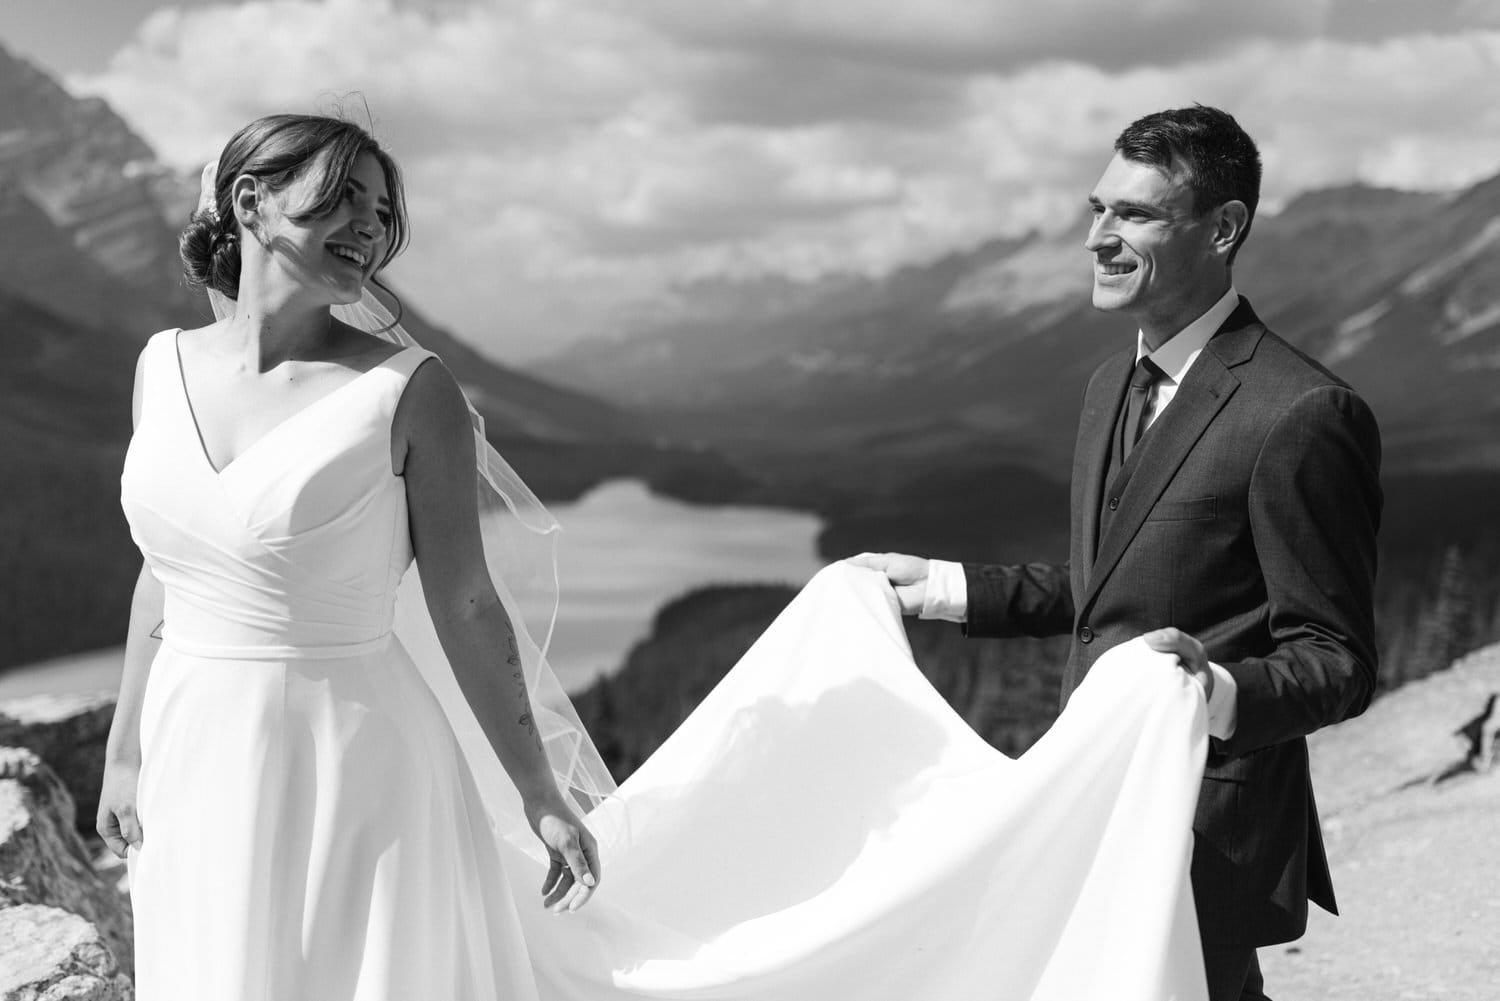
95 353 162 858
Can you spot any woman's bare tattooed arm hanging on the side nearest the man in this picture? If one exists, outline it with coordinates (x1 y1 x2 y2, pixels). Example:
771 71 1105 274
392 360 599 909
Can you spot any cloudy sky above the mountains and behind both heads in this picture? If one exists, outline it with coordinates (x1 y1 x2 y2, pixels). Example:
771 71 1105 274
0 0 1500 363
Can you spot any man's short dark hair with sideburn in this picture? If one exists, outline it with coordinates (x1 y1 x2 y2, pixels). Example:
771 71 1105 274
1115 105 1260 264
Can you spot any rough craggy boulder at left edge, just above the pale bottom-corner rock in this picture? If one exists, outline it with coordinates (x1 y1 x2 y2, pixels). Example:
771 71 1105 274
0 747 134 978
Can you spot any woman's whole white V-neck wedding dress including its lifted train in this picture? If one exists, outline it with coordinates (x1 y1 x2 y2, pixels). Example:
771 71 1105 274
122 332 1208 1001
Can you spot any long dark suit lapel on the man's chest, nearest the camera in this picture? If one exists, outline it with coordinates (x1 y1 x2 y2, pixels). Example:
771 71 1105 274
1082 299 1265 608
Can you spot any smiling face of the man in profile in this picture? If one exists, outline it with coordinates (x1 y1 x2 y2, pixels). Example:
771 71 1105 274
1085 153 1217 332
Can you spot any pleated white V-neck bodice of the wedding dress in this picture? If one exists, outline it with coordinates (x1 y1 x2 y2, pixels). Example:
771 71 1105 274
122 330 431 659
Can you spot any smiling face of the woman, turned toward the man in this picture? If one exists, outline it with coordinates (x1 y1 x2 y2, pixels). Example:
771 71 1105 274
250 153 392 303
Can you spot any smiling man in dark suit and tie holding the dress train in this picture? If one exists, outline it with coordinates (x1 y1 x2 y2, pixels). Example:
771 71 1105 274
855 107 1382 1001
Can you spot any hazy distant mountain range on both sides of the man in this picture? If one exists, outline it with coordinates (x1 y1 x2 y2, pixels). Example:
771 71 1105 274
536 170 1500 474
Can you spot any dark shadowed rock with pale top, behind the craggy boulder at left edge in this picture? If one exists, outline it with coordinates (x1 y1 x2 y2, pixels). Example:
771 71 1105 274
0 692 114 839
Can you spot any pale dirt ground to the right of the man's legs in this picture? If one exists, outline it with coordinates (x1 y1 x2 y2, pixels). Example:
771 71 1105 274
1262 647 1500 1001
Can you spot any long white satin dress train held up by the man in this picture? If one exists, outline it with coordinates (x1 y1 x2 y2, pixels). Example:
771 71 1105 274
504 564 1208 1001
